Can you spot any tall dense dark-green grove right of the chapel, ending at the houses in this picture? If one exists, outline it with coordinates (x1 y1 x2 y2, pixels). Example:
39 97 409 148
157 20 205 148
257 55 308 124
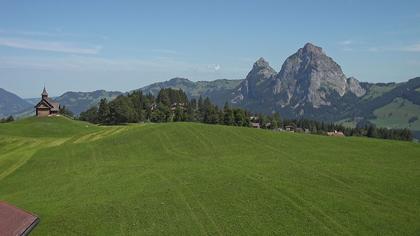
79 88 254 126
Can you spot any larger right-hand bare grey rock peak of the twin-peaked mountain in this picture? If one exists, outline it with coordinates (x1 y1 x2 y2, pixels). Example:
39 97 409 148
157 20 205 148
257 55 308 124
273 43 364 108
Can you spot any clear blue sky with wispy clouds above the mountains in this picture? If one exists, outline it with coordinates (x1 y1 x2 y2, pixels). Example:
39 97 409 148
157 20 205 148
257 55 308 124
0 0 420 97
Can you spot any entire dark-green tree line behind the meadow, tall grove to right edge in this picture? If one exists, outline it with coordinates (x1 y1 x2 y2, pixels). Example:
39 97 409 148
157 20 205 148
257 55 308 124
79 88 412 140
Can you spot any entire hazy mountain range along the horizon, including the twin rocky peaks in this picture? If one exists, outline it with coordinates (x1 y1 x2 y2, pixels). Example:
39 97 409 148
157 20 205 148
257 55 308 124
0 43 420 136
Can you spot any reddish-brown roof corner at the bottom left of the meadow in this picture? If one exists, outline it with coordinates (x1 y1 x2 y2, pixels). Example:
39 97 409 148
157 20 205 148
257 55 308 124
0 202 39 235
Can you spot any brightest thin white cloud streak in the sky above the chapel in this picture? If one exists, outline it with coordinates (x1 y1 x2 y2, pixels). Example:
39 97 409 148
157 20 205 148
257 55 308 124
0 37 102 54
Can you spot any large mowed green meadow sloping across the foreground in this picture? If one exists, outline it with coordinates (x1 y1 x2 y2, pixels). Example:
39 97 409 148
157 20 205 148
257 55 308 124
0 117 420 235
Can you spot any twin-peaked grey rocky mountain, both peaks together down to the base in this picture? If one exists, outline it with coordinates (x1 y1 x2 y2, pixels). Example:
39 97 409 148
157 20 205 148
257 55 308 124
230 43 366 117
